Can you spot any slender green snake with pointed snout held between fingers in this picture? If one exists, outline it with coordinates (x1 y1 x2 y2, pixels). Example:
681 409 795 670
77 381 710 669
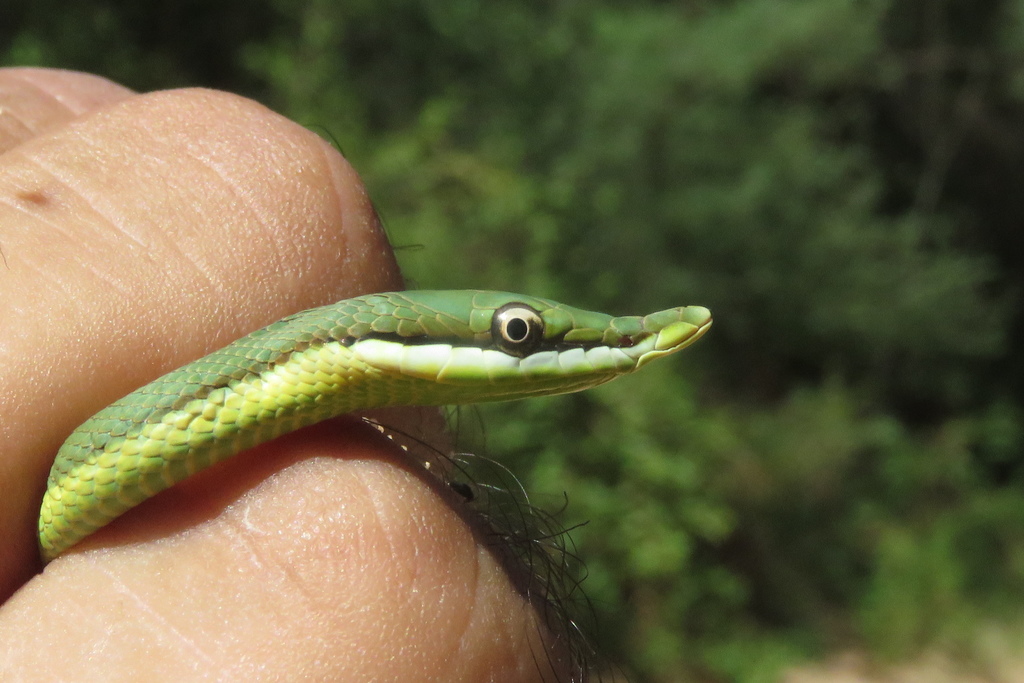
39 290 712 562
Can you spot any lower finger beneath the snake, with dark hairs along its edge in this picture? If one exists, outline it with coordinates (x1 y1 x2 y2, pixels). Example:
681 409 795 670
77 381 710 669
0 423 568 682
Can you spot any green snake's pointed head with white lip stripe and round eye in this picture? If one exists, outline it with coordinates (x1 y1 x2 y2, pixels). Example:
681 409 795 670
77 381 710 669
351 291 712 403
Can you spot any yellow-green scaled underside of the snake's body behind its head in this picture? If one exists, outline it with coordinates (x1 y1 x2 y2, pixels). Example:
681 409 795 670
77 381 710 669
39 342 612 560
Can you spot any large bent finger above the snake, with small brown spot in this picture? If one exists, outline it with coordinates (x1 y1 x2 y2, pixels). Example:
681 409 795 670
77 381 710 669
0 85 399 595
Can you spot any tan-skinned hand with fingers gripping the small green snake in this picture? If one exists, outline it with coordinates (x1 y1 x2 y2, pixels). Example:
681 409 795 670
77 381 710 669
0 69 566 681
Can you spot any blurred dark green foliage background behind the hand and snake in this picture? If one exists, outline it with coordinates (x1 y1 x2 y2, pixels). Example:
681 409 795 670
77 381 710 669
0 0 1024 683
